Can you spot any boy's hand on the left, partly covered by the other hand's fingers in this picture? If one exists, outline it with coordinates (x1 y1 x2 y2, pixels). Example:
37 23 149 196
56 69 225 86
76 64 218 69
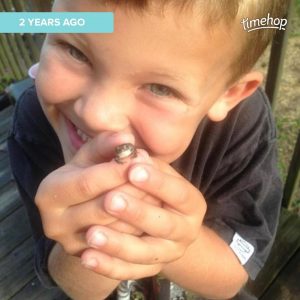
35 134 155 255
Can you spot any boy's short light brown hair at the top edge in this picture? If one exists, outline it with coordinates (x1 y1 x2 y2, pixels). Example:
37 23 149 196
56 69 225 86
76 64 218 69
101 0 289 82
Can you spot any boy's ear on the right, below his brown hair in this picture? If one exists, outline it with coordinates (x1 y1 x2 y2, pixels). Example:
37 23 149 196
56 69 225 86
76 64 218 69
207 71 263 122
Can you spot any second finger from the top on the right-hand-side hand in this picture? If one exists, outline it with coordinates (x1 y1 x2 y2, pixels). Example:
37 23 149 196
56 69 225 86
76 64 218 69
104 192 192 240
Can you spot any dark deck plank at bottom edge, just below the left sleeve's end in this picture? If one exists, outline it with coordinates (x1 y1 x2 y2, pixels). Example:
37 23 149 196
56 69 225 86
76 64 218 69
10 276 70 300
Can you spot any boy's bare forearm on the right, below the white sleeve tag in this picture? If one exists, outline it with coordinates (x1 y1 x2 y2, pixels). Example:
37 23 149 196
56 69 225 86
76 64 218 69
162 226 248 299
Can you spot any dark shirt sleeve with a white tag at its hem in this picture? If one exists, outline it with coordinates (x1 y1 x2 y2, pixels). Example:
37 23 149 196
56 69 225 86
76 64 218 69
205 90 282 279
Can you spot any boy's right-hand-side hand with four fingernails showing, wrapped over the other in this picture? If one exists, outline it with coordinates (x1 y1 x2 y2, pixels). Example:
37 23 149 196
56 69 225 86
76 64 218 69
81 161 206 280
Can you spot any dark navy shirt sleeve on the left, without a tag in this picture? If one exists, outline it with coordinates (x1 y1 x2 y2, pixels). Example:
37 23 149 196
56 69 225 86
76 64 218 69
7 88 63 287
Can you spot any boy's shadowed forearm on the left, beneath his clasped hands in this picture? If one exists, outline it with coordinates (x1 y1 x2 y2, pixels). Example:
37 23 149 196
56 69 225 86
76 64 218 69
48 244 119 300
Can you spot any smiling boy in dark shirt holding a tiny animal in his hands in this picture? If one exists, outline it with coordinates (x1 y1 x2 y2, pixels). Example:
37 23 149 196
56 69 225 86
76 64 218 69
9 0 286 300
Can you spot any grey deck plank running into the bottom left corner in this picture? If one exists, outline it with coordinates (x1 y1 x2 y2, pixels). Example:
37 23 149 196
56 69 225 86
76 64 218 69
0 238 34 300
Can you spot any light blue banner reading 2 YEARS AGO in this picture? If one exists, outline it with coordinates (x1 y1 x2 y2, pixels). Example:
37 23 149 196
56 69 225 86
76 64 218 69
0 12 114 33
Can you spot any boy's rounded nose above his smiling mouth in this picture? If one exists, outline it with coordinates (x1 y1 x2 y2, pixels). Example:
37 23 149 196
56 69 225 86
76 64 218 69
75 86 130 132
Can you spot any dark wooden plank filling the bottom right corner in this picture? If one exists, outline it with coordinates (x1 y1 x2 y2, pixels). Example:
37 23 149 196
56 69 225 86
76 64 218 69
261 250 300 300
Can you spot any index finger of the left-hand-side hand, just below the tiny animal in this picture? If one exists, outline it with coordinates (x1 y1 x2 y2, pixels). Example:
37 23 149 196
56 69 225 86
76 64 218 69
35 161 128 210
